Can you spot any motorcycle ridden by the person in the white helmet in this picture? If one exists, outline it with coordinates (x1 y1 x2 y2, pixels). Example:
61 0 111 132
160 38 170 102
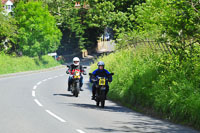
66 66 87 97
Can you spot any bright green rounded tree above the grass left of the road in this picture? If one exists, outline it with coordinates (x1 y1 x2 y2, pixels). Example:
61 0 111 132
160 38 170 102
14 1 62 57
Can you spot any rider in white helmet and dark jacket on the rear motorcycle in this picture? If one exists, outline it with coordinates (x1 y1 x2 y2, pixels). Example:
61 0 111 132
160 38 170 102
66 57 86 91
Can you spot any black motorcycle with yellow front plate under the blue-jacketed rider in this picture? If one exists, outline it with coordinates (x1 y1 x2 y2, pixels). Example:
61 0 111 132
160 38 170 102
89 73 114 108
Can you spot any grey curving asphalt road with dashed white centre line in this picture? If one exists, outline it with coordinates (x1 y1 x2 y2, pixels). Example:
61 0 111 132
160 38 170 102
0 57 197 133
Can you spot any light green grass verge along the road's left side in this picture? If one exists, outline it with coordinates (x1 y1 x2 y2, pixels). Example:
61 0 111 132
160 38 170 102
0 54 60 74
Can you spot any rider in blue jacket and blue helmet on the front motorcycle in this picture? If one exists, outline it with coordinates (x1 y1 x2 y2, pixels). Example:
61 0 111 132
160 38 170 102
90 61 112 100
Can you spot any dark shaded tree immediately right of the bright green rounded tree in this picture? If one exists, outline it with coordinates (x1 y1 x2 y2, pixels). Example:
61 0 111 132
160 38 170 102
45 0 88 53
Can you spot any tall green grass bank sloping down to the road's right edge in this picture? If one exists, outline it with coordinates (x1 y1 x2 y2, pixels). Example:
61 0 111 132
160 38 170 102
91 47 200 129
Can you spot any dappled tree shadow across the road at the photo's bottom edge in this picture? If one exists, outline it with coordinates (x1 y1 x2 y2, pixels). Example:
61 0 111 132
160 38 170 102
87 119 197 133
